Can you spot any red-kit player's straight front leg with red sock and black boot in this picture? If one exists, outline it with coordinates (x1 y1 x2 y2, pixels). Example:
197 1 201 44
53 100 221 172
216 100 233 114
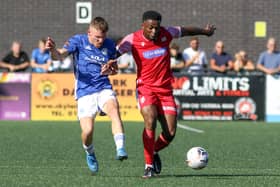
141 105 158 178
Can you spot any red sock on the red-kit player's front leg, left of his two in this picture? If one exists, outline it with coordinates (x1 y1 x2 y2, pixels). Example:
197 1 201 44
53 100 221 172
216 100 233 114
142 129 155 165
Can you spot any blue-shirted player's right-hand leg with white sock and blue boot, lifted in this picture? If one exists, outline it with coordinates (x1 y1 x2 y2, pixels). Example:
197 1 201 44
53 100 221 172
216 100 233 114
102 99 128 161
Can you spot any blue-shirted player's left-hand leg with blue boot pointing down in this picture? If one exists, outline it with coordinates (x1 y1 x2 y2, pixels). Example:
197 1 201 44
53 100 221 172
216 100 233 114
80 117 98 174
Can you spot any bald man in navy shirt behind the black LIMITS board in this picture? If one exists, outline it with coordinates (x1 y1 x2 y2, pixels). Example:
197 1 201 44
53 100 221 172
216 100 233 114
210 41 233 74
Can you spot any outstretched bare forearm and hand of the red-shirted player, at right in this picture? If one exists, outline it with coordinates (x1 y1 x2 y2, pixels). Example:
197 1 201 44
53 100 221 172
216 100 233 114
181 24 216 37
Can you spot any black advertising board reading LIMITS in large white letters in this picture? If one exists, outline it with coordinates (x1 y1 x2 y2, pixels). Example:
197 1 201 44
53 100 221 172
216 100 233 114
172 73 265 120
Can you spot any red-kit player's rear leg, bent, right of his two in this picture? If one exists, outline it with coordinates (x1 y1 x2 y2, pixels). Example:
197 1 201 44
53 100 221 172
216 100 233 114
153 114 177 174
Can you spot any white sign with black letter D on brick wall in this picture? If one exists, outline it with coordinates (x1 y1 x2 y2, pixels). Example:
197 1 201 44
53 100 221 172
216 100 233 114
76 2 92 23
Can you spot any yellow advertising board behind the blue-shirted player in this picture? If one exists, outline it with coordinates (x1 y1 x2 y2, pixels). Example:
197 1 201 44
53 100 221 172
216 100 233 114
31 73 142 121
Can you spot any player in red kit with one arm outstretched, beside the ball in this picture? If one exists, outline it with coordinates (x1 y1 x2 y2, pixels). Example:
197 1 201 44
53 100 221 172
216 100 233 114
102 11 216 178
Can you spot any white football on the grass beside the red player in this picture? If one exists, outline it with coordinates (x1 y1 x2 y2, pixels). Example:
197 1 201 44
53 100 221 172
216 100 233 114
186 147 208 169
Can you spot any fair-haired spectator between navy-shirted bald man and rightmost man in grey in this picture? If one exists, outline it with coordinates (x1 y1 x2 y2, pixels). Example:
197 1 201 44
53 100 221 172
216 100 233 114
233 51 255 72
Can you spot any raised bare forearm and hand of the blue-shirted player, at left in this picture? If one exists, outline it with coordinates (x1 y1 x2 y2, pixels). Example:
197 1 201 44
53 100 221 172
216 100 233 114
46 37 68 60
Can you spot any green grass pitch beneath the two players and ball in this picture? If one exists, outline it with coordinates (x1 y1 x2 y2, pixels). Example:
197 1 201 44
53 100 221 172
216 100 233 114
0 121 280 187
